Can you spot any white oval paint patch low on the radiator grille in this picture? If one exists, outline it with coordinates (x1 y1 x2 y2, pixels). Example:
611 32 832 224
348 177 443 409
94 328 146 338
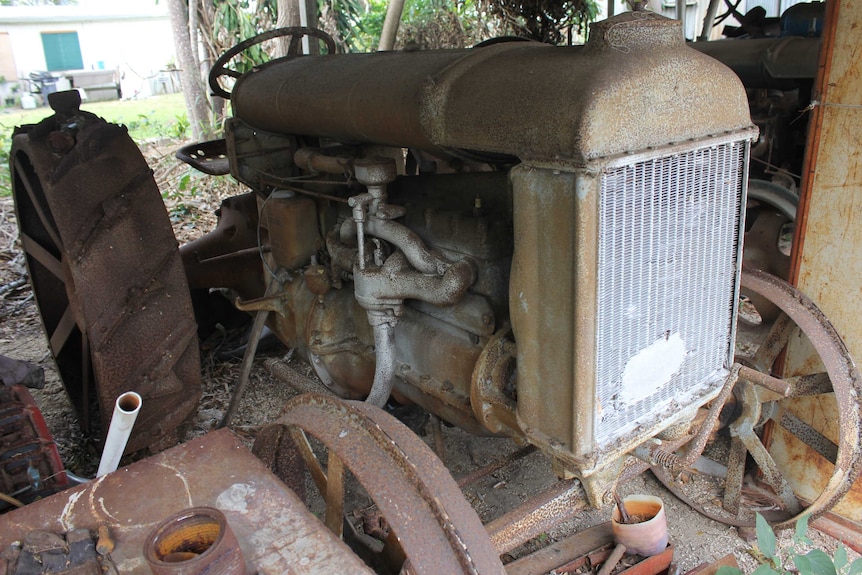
618 333 685 404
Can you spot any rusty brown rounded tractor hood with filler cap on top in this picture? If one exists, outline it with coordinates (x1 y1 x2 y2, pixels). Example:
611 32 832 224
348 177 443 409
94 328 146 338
232 12 751 164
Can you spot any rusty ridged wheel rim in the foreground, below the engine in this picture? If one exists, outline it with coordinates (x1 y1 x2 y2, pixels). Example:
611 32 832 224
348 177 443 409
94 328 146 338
255 394 504 574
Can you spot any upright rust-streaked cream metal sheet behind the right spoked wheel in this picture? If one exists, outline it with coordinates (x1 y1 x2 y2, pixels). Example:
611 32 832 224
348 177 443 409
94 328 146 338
788 1 862 521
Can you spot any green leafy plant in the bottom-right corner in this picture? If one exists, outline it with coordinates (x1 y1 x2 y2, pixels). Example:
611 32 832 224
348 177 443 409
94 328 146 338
716 513 862 575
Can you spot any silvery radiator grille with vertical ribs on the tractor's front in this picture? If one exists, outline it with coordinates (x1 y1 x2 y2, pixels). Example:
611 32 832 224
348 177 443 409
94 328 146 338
594 140 748 450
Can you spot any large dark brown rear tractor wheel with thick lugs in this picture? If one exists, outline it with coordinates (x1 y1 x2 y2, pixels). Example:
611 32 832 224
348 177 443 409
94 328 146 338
10 93 200 451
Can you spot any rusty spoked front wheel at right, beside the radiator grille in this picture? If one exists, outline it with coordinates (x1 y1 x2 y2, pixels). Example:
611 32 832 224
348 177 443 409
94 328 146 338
653 271 862 526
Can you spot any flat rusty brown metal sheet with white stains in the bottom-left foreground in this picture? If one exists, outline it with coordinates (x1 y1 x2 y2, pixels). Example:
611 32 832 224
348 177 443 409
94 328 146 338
0 430 372 575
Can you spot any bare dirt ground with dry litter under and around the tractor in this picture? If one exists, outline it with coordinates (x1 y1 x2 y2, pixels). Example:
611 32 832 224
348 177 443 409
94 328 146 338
0 155 855 573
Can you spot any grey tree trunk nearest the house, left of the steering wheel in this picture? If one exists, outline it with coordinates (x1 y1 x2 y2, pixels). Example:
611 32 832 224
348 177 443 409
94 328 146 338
168 0 213 141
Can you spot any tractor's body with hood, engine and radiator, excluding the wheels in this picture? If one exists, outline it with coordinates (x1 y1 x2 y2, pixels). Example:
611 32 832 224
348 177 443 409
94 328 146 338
182 12 757 503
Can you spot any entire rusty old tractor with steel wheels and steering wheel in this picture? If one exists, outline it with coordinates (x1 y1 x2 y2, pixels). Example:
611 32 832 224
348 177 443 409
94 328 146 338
12 5 862 572
